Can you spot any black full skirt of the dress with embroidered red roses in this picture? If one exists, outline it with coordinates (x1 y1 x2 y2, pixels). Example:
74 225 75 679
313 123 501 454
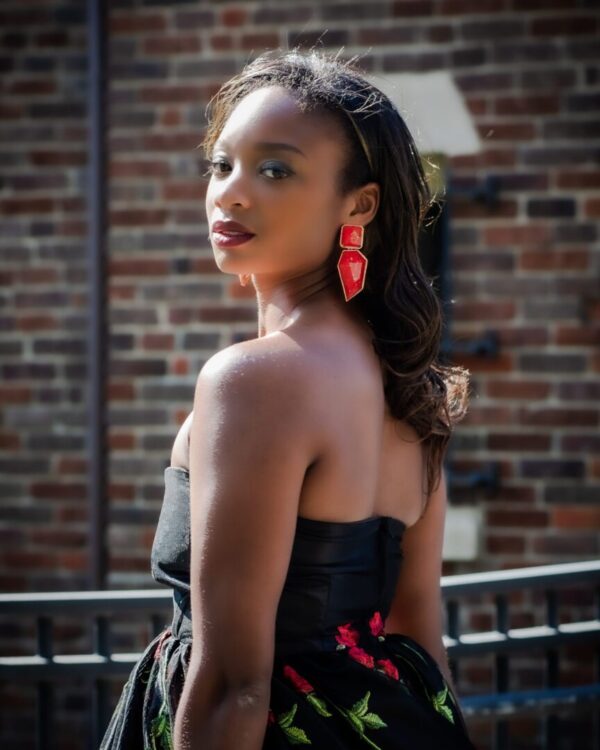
100 613 474 750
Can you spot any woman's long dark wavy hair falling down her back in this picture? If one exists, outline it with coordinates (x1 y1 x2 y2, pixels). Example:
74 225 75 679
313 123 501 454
203 50 469 502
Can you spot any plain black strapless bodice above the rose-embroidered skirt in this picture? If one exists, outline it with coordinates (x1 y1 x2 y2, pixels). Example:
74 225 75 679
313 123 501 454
151 467 405 647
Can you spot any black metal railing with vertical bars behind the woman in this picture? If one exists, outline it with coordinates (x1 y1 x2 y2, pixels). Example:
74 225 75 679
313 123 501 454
0 561 600 750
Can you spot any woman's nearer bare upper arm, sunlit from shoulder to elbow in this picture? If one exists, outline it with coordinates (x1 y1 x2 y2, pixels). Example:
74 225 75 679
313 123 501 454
189 347 310 689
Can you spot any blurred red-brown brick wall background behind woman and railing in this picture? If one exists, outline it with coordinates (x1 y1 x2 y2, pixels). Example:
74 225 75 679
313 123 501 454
0 0 600 749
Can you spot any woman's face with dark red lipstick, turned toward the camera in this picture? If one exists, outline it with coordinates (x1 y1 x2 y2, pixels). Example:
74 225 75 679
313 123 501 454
206 86 351 283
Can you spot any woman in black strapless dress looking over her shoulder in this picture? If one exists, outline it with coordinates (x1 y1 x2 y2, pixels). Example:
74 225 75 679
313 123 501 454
102 51 472 750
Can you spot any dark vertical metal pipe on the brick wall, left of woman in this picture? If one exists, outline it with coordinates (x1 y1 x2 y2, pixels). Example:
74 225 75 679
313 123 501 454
87 0 106 589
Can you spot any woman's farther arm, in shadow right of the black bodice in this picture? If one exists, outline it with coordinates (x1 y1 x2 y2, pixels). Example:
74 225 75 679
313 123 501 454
386 469 447 660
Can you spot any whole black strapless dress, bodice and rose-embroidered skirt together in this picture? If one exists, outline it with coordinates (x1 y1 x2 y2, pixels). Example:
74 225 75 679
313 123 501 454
101 467 474 750
